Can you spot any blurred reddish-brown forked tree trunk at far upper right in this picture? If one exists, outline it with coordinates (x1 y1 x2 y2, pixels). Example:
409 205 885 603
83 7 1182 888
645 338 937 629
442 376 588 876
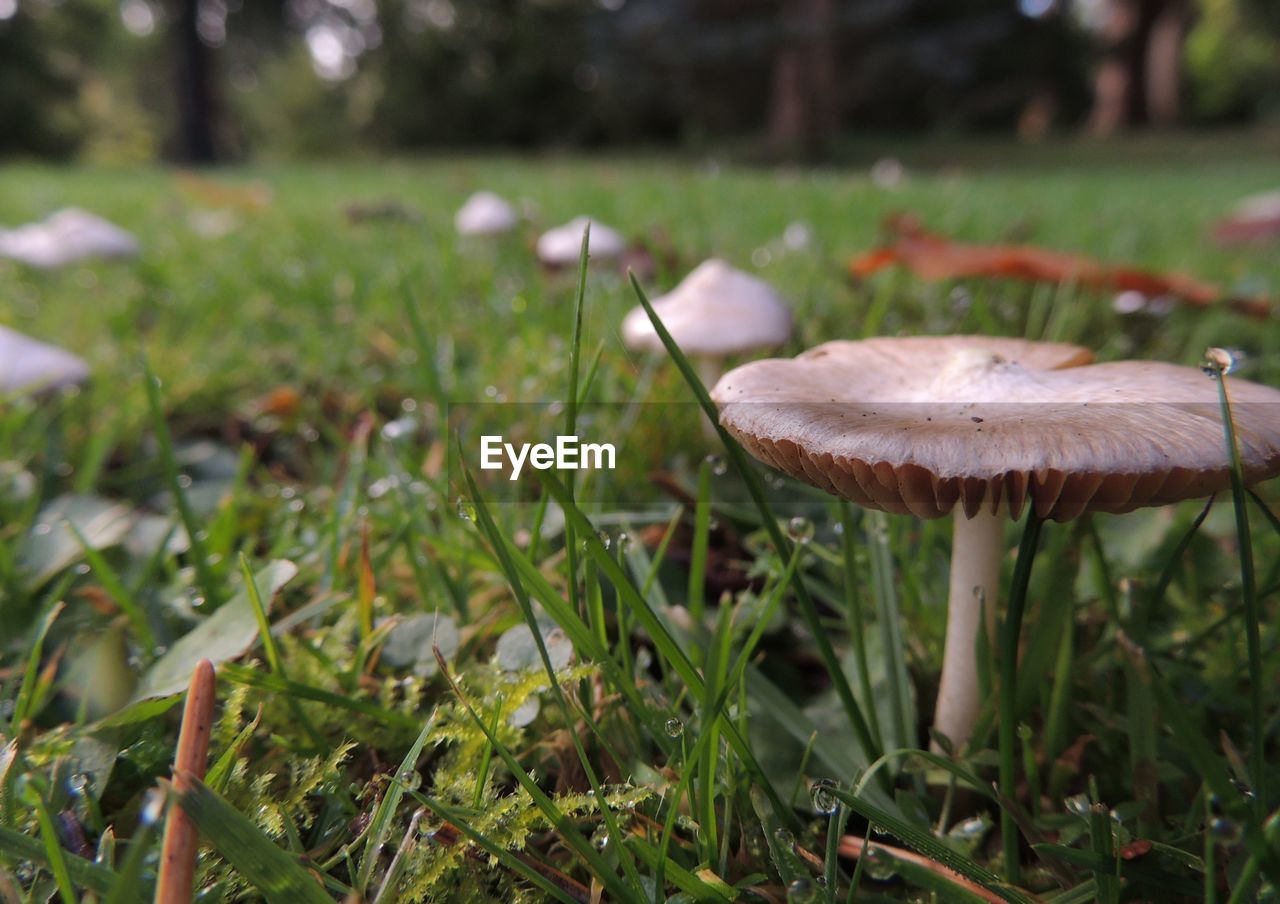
1089 0 1188 137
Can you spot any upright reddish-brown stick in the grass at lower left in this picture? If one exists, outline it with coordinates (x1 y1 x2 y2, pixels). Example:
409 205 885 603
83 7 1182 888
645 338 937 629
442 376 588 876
156 659 216 904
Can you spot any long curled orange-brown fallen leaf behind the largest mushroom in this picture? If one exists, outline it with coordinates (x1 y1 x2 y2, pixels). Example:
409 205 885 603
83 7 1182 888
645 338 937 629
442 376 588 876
849 214 1272 318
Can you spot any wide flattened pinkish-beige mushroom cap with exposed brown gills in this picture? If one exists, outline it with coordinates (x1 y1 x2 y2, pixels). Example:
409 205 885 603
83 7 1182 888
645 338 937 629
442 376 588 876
712 335 1280 521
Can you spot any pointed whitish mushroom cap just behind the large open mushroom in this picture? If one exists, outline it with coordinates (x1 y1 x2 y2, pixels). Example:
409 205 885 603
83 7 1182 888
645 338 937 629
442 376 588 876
622 259 791 356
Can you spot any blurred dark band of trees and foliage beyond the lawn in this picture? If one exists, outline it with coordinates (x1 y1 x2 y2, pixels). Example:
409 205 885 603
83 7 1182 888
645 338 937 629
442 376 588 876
0 0 1280 161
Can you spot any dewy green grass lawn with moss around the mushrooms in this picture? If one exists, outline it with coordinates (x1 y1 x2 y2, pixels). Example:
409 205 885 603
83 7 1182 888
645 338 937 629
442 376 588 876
0 149 1280 903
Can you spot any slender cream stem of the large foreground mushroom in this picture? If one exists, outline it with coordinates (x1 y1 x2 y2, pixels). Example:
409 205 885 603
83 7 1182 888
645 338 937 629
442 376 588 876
933 507 1005 752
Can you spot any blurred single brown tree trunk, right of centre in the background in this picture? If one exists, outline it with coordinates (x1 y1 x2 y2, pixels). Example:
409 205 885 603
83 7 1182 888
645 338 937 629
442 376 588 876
768 0 840 160
